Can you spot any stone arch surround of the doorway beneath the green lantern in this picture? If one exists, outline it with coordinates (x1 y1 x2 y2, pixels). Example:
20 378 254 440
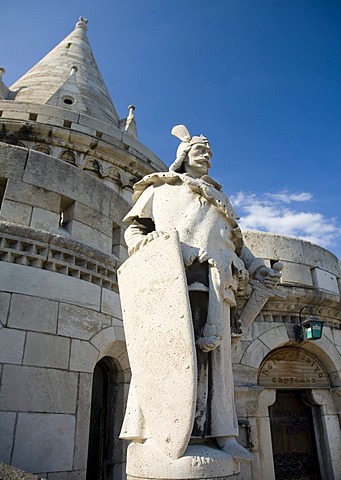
234 334 341 479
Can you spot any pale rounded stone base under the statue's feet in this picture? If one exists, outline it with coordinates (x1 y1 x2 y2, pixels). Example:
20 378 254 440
127 439 240 480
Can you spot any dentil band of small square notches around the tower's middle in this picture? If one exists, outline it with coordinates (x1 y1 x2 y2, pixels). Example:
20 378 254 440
0 222 119 291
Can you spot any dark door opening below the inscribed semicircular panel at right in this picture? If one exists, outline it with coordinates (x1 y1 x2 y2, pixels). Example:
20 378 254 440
269 390 321 480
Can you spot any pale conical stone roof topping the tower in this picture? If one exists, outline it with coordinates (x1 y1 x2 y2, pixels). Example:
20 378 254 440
10 17 119 126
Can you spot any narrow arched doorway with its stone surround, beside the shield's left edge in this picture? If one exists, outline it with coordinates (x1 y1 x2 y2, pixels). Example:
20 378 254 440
86 336 131 480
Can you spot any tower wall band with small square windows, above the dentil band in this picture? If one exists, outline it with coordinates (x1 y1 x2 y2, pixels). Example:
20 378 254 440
0 144 130 259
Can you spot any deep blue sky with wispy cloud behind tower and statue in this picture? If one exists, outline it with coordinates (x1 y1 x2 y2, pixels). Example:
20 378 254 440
0 0 341 257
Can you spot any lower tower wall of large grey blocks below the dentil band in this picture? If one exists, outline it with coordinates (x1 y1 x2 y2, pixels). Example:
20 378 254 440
0 226 129 480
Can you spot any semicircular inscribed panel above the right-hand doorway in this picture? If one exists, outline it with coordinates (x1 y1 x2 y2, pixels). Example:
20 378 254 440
258 348 330 389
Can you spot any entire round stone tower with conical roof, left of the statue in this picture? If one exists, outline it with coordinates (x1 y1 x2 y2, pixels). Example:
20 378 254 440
0 18 165 480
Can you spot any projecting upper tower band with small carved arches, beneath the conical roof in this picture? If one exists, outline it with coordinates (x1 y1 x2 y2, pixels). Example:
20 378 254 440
0 100 166 202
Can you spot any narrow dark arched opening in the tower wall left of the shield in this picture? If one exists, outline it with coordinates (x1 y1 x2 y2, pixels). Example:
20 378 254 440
86 357 117 480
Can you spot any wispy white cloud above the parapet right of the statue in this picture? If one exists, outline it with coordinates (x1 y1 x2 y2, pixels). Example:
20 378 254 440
231 191 341 248
